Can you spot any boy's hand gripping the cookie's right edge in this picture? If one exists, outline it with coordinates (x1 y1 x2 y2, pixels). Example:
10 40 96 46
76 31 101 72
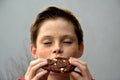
69 57 92 80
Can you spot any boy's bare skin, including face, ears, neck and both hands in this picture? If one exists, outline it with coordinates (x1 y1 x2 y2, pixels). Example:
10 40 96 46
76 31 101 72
25 18 92 80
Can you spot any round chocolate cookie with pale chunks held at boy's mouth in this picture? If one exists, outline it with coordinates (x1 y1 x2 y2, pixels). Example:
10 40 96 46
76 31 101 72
42 57 75 73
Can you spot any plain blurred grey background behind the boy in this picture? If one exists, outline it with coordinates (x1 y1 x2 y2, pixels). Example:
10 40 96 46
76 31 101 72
0 0 120 80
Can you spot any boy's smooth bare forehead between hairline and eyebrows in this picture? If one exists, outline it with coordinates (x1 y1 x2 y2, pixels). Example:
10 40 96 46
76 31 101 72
39 18 75 35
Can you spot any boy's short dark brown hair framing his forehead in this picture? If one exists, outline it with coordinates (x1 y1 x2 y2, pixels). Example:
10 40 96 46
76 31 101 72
30 6 83 46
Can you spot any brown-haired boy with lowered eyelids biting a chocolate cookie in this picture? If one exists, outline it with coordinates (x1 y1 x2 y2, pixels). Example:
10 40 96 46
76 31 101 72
19 7 93 80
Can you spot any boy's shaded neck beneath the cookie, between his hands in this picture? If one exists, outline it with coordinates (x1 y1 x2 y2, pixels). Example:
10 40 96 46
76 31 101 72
48 72 70 80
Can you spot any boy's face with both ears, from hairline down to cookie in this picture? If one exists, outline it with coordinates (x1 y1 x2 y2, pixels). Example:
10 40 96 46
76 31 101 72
31 18 83 59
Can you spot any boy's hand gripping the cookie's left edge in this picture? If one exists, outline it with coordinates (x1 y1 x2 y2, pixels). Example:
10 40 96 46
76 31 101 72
25 58 49 80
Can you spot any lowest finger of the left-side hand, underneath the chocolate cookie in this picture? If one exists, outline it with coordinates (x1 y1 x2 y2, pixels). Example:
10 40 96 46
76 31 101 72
33 70 49 80
